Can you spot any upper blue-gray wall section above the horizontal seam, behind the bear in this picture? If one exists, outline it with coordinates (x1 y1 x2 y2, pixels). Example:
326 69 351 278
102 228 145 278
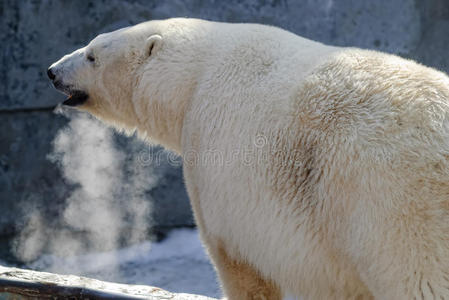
0 0 424 109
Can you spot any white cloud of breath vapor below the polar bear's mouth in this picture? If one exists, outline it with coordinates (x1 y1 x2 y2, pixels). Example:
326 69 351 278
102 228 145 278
15 112 157 273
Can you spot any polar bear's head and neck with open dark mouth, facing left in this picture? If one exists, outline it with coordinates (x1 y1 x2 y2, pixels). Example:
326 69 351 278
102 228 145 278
48 18 207 150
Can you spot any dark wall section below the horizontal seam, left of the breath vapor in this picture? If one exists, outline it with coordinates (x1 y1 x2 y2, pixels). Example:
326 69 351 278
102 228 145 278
0 111 69 234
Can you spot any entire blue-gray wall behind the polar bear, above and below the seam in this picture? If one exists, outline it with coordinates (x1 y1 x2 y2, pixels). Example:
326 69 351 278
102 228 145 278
0 0 449 262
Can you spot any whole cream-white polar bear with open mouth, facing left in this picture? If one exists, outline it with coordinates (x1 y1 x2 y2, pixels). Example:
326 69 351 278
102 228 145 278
48 18 449 300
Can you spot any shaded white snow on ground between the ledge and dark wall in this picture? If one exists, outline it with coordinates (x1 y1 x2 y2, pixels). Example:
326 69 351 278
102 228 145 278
29 229 221 298
